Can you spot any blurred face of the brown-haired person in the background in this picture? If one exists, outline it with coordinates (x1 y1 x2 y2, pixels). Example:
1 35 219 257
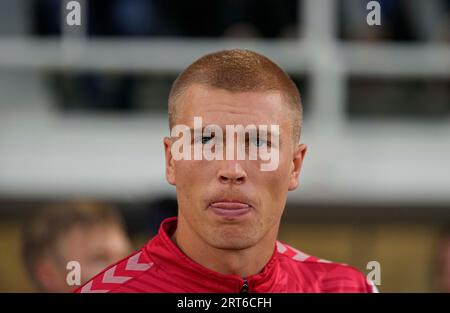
36 224 131 292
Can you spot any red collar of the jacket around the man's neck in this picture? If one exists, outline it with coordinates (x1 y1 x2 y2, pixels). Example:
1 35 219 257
145 217 280 292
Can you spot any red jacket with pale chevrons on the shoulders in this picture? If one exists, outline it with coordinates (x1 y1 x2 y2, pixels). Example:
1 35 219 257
75 218 376 293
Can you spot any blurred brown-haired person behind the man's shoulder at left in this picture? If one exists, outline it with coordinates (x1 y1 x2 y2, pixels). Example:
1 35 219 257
22 201 131 292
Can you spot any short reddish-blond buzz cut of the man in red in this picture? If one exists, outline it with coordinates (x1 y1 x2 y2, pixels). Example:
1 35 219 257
169 49 303 143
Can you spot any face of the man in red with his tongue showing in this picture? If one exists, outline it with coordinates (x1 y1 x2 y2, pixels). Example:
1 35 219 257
164 85 306 249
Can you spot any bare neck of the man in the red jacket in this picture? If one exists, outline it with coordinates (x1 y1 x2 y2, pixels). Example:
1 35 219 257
171 214 278 278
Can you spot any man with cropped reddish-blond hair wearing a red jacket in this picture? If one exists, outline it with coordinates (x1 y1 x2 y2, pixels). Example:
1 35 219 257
77 50 374 292
